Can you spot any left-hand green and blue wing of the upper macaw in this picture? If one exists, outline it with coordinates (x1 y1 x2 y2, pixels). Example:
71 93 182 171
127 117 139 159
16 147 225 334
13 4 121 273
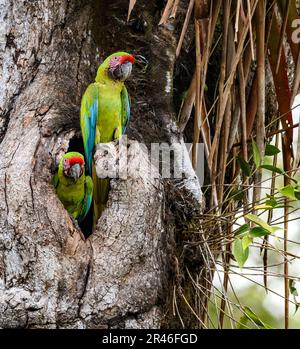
80 84 99 175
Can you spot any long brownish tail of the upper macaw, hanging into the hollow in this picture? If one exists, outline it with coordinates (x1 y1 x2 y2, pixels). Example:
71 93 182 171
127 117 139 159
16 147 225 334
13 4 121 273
92 166 110 230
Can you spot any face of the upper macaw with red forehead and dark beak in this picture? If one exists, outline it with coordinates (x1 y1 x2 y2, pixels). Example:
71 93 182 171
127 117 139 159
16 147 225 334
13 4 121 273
108 55 134 81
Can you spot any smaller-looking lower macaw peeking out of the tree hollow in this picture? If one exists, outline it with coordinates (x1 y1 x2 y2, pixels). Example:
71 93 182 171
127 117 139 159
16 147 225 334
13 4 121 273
53 152 93 223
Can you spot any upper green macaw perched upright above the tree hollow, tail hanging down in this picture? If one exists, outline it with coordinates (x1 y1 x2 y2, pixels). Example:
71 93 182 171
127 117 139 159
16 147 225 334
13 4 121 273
80 52 135 227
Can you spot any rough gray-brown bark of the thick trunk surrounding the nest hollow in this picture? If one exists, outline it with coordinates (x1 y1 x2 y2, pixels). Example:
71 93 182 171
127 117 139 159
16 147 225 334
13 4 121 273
0 0 200 328
